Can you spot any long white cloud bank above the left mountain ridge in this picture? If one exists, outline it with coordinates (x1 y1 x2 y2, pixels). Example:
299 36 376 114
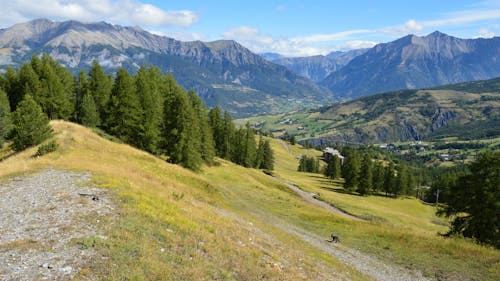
0 0 198 27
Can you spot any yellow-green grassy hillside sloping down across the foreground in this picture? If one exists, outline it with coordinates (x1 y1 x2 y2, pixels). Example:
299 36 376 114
0 121 500 280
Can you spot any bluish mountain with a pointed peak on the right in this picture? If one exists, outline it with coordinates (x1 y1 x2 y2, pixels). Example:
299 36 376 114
321 31 500 98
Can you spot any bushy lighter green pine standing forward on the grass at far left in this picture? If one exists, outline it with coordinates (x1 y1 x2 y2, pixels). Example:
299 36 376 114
11 95 52 151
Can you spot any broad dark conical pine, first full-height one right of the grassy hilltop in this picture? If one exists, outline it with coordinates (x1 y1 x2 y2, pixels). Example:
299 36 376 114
105 68 143 146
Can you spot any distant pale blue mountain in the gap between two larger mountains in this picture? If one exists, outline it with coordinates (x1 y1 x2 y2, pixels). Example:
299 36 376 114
261 49 367 83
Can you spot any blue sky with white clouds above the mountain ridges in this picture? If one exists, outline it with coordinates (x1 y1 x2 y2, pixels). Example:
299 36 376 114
0 0 500 57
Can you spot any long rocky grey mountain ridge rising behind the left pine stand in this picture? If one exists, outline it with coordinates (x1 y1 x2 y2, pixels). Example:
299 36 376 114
0 19 332 116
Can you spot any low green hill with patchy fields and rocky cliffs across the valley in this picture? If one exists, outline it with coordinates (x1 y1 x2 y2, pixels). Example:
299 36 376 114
240 78 500 145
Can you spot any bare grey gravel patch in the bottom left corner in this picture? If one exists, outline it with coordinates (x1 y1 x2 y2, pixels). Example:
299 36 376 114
0 170 113 280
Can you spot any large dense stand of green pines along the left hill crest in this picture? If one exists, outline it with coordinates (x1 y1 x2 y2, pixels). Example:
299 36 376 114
0 54 274 170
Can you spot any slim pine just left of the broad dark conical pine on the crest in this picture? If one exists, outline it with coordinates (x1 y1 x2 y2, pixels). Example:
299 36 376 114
89 61 113 123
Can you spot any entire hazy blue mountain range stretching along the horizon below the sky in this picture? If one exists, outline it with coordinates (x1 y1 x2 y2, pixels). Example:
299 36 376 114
0 19 500 117
